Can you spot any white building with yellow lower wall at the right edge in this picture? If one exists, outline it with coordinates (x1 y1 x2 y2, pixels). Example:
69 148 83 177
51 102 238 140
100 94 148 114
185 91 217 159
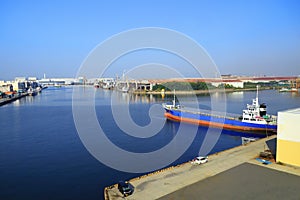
276 108 300 167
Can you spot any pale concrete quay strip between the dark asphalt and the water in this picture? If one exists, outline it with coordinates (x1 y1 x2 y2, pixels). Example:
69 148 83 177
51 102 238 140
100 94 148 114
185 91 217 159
104 135 300 200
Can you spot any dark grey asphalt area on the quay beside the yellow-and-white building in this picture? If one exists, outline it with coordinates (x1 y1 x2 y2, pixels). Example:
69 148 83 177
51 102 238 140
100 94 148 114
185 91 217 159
159 163 300 200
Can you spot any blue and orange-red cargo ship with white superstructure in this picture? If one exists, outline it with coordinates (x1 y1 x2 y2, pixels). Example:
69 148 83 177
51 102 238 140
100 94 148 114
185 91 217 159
162 88 277 132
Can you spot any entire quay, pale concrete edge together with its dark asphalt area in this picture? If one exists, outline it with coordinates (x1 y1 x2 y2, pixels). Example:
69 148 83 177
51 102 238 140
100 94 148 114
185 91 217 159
104 135 300 200
